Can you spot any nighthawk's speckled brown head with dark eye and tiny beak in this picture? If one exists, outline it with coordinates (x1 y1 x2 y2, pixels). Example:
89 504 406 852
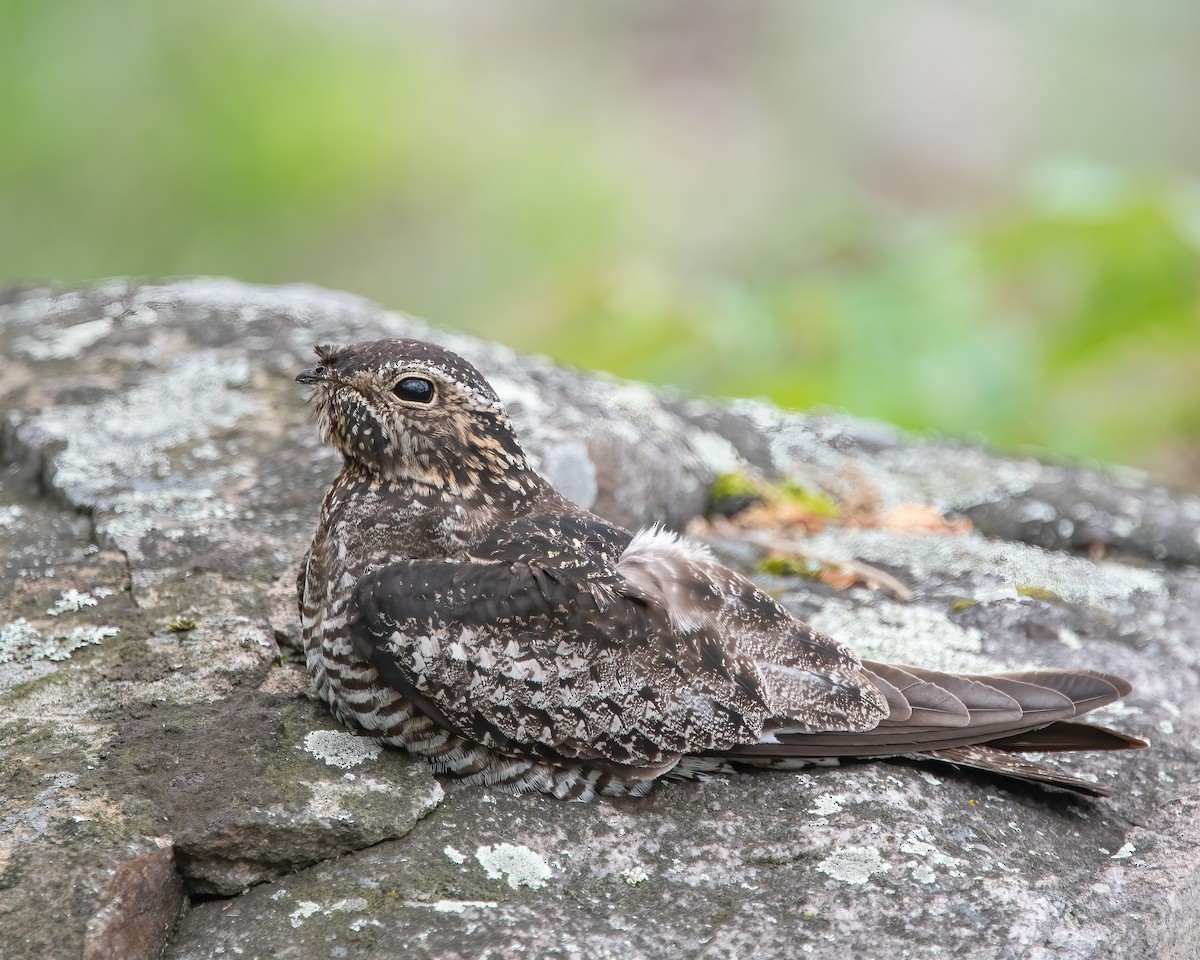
296 340 535 496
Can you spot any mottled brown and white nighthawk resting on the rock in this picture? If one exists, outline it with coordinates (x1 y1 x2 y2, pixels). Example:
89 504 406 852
296 340 1144 799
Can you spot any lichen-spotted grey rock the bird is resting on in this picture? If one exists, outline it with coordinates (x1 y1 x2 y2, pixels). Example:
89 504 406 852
0 280 1200 960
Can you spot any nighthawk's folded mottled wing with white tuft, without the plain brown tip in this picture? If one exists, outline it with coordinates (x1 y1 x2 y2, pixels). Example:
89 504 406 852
350 524 887 766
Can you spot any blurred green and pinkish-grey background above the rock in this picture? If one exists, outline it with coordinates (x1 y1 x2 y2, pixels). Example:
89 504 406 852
0 0 1200 486
